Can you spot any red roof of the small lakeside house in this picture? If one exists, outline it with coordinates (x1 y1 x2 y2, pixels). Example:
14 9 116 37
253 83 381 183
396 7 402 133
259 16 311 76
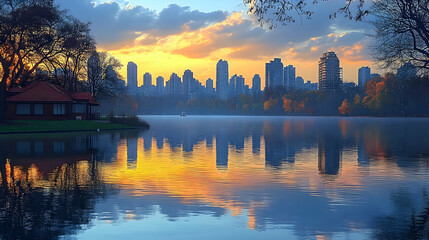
7 82 98 105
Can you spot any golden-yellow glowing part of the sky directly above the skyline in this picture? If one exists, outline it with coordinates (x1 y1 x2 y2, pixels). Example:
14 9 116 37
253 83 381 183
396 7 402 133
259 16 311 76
100 12 373 88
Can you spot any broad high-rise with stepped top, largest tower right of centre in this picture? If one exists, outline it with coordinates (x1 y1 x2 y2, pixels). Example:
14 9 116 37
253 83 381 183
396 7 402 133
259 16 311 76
319 52 342 93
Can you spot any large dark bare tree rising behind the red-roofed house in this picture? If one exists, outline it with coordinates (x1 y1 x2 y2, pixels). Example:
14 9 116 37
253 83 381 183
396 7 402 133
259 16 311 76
0 0 95 122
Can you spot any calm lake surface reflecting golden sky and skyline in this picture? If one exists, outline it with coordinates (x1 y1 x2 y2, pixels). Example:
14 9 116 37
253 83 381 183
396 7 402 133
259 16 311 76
0 116 429 240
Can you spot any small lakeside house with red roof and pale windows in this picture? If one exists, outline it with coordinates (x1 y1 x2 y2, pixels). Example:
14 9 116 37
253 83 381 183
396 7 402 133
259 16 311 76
6 82 99 120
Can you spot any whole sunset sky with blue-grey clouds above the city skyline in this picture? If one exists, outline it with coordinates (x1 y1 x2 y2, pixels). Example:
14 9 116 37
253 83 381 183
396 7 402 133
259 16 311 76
56 0 377 85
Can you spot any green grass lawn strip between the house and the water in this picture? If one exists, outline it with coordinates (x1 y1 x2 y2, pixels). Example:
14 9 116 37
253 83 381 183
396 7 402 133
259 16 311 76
0 120 132 133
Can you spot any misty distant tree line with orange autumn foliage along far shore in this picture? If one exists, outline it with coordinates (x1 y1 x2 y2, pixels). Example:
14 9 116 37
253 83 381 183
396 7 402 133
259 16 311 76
102 73 429 116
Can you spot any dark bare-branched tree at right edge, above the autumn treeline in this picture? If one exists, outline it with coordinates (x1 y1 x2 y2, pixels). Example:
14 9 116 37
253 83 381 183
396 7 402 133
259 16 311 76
372 0 429 69
